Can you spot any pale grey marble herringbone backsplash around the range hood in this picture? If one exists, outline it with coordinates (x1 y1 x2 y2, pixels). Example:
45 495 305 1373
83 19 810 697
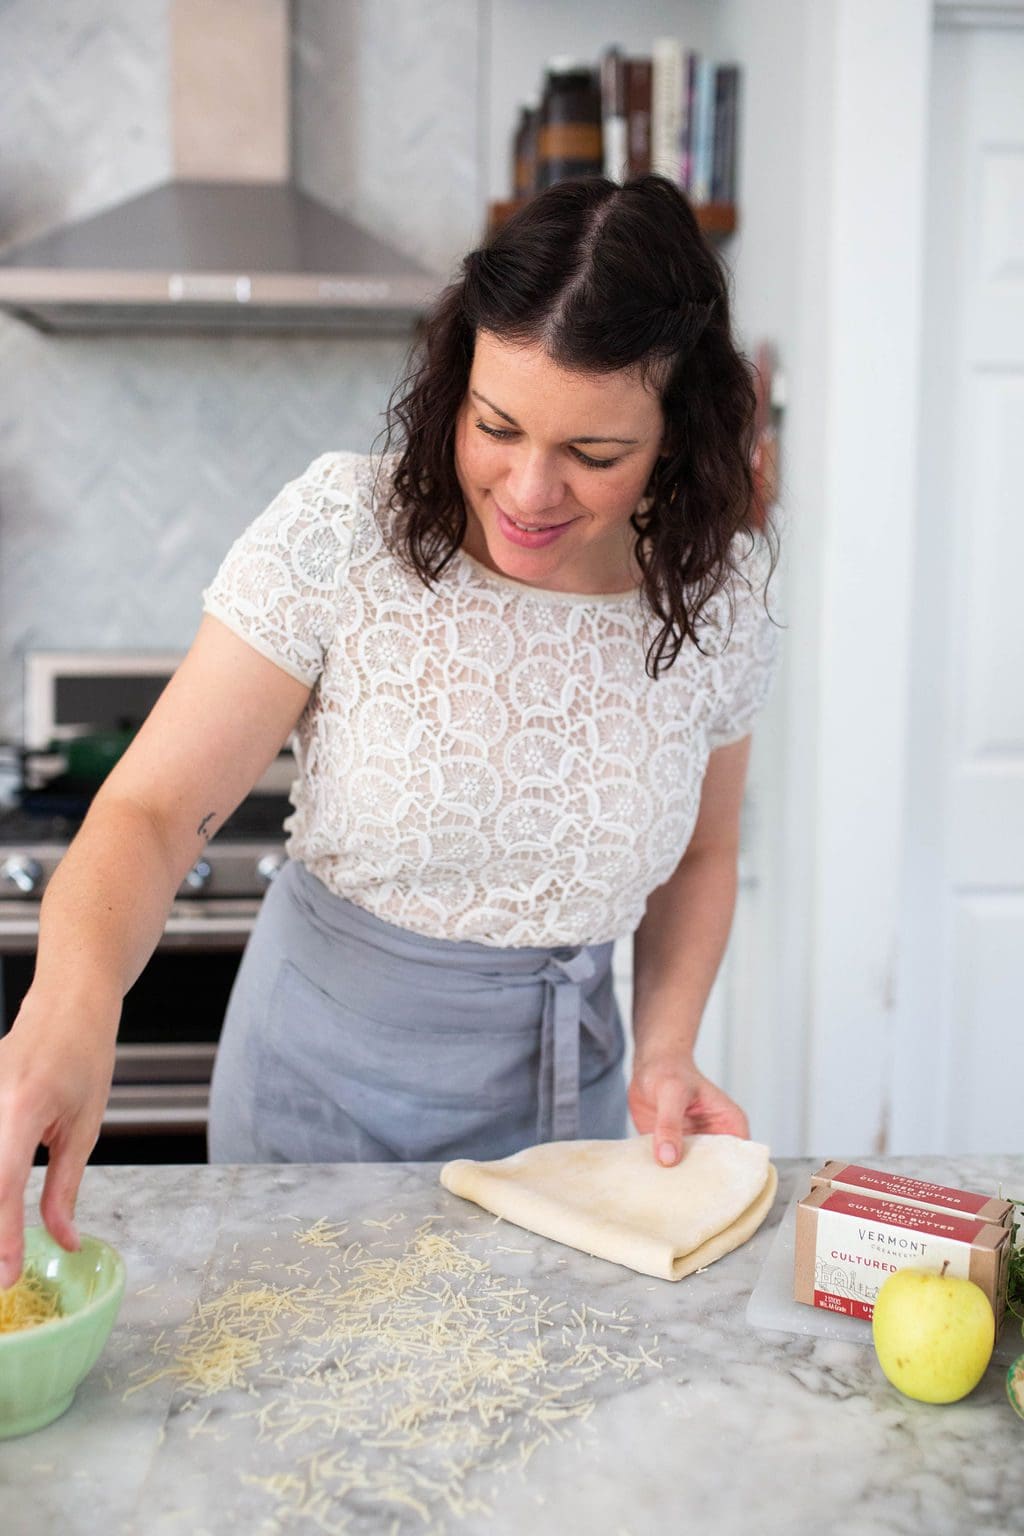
0 0 484 739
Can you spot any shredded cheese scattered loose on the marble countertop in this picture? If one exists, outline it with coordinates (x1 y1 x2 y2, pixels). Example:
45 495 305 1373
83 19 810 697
129 1218 660 1536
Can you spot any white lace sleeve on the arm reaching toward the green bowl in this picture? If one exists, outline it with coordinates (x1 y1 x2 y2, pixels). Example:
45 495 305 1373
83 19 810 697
203 453 358 687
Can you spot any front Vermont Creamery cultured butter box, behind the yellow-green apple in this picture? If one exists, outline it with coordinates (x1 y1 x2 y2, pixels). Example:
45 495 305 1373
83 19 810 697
794 1184 1010 1329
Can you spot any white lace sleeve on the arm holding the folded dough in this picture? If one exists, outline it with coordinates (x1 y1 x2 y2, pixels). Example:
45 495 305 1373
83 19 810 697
708 539 778 751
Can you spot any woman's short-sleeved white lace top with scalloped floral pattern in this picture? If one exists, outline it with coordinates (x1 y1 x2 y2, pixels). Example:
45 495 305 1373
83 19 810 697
204 453 775 946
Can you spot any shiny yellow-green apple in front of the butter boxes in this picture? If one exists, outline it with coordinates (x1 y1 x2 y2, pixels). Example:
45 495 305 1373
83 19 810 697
870 1269 995 1402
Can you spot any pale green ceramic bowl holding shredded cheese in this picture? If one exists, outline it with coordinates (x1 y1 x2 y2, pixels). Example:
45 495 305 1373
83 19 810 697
0 1227 124 1439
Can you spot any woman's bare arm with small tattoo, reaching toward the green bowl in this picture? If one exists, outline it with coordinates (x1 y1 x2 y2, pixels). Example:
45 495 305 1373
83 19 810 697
0 616 310 1287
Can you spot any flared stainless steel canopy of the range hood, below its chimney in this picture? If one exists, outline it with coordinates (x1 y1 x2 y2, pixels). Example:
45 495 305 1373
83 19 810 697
0 181 438 332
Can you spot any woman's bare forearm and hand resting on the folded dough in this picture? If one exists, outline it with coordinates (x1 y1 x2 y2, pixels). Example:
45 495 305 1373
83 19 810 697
629 736 751 1166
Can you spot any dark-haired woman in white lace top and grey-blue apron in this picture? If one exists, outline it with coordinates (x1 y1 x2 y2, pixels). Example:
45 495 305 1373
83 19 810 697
0 177 774 1284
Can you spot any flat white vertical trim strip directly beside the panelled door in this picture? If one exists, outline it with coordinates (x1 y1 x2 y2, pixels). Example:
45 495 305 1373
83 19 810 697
804 0 932 1155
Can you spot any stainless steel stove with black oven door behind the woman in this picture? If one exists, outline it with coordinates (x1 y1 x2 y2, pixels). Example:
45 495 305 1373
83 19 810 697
0 651 295 1161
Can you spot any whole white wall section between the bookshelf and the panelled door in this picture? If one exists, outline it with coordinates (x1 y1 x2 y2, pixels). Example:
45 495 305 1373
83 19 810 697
722 0 930 1155
